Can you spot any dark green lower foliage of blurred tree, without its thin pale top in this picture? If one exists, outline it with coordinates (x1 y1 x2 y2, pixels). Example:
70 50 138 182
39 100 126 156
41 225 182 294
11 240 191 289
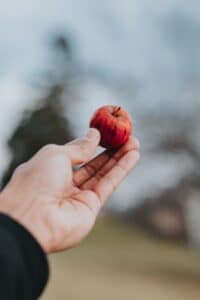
2 86 72 186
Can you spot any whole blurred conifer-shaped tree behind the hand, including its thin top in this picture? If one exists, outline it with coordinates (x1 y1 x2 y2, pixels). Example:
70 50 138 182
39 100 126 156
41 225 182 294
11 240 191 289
2 35 76 186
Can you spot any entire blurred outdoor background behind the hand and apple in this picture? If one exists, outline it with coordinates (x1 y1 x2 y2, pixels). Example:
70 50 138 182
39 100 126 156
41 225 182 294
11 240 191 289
0 0 200 300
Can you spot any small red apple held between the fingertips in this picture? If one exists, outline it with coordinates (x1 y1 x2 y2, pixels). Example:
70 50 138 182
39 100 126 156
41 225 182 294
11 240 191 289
90 105 133 149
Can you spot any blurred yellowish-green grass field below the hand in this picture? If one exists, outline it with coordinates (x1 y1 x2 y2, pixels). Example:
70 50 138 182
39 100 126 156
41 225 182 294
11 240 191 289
42 219 200 300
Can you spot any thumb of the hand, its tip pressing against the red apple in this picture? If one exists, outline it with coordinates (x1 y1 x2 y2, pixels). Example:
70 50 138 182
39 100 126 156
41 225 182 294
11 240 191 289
64 128 100 165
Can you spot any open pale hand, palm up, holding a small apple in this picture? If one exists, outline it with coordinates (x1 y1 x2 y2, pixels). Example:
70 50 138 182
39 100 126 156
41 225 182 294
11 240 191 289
0 129 139 253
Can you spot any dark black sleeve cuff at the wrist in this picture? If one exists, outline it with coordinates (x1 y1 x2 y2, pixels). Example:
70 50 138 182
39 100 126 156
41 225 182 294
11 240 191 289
0 214 49 300
